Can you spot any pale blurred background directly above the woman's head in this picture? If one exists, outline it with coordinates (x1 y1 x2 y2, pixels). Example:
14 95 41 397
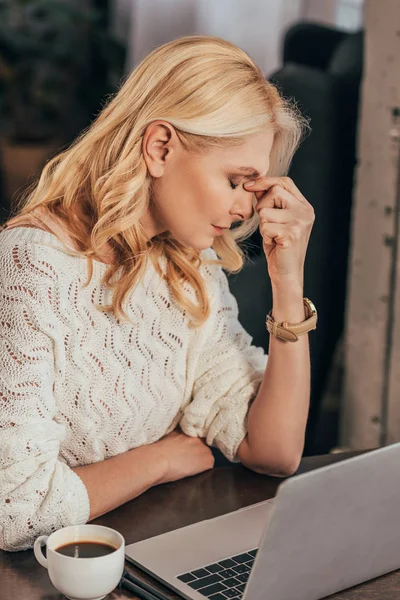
113 0 363 77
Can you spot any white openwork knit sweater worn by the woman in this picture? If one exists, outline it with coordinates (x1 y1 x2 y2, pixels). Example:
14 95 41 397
0 227 267 550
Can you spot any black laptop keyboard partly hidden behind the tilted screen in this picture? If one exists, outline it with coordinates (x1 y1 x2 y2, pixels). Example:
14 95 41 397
178 548 257 600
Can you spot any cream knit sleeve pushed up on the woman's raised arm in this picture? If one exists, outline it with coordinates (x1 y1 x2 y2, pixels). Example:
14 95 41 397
180 254 268 462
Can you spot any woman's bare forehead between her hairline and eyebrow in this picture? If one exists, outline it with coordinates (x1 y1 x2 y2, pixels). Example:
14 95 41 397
214 129 274 175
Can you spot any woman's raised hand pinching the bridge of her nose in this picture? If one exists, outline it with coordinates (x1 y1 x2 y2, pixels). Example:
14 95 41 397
243 177 315 283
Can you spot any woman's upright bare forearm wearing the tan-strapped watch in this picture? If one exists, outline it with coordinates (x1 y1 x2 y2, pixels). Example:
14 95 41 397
238 283 310 476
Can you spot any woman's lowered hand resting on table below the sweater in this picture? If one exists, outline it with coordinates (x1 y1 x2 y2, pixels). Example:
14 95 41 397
154 431 214 483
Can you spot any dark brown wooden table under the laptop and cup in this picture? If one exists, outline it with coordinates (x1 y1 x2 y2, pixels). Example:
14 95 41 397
0 453 400 600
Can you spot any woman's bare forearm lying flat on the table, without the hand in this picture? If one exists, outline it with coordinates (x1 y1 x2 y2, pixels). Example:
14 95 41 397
72 444 165 520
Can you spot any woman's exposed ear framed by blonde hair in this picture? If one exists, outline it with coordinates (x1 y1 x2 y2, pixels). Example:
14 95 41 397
143 121 179 177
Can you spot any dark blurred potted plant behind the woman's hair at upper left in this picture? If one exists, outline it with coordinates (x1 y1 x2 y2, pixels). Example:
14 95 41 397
0 0 124 202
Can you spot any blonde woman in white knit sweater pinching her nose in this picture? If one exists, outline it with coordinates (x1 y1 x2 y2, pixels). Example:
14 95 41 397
0 35 314 550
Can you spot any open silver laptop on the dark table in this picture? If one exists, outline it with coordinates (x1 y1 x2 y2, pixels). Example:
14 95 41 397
126 443 400 600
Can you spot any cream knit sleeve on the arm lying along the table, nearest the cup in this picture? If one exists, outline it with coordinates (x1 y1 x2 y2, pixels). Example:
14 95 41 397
0 254 90 550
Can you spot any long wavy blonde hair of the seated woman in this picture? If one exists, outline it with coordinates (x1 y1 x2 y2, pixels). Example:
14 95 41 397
4 35 305 326
